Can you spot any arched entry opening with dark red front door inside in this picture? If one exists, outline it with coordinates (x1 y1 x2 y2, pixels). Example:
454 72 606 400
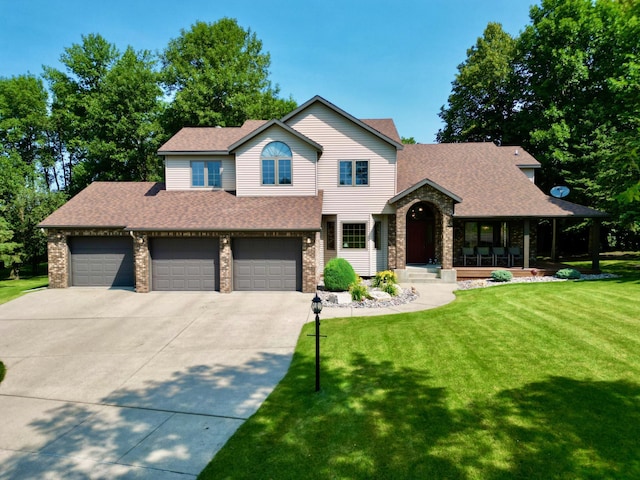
407 203 435 264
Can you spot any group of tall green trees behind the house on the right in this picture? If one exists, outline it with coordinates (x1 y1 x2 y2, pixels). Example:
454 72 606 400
437 0 640 249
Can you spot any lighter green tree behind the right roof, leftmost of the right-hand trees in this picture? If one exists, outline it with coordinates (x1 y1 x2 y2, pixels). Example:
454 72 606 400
436 23 518 144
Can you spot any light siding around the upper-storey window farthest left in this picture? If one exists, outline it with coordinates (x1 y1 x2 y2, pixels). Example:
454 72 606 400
165 155 236 190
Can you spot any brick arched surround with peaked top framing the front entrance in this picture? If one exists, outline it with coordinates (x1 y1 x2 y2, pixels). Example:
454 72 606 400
389 185 453 270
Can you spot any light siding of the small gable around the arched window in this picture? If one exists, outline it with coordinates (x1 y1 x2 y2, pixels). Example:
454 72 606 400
236 126 318 197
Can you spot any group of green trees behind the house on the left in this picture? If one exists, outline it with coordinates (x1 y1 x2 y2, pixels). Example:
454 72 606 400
0 18 296 276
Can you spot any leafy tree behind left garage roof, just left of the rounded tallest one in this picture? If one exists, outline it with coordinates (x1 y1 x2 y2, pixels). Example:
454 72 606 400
45 35 163 193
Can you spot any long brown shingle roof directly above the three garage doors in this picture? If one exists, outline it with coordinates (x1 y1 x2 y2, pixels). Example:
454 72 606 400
40 182 322 231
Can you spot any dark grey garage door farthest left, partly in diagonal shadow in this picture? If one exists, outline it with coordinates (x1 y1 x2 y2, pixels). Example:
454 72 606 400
69 237 134 287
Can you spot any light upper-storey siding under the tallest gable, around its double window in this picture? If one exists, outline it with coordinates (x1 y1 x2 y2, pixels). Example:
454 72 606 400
290 104 397 214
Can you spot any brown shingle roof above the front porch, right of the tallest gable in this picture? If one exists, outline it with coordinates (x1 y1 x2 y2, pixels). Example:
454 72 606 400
396 143 606 217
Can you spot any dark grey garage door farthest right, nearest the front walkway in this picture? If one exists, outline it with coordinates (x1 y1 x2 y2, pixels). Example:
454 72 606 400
232 238 302 291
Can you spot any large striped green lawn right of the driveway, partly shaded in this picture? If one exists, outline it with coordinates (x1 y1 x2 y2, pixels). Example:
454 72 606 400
200 257 640 479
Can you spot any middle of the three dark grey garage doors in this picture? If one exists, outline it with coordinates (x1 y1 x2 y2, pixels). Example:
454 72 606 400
151 238 219 291
